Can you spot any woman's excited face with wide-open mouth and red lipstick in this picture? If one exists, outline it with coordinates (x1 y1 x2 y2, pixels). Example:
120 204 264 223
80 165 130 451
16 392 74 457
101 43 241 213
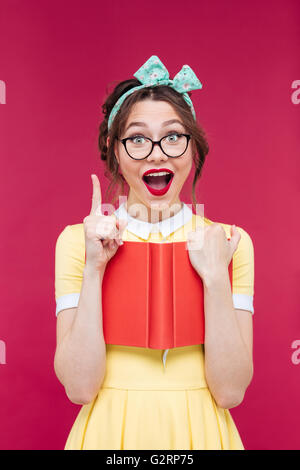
115 100 193 220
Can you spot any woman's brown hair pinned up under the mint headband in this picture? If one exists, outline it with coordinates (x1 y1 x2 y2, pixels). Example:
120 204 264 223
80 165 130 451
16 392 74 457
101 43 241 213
98 78 209 211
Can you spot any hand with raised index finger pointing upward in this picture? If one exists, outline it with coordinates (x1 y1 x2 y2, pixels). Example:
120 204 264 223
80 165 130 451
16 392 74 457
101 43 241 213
83 175 127 270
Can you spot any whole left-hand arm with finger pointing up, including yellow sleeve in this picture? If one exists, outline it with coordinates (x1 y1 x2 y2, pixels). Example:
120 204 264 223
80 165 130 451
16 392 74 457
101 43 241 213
54 175 127 404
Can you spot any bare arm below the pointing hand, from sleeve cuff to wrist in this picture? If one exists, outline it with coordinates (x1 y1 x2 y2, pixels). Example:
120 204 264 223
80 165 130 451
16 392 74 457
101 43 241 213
54 266 106 404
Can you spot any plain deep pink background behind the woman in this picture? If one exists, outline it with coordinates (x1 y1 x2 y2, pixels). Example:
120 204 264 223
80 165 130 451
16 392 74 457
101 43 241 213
0 0 300 449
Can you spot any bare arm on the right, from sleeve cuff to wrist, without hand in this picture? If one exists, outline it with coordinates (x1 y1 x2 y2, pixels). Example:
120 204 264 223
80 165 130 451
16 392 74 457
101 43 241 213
203 270 253 408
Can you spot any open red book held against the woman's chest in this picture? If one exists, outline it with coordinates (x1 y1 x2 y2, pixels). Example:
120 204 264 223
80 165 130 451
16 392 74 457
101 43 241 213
102 241 232 349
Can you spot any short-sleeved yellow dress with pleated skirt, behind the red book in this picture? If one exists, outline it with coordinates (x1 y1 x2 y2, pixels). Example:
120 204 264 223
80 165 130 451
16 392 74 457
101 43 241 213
55 206 254 450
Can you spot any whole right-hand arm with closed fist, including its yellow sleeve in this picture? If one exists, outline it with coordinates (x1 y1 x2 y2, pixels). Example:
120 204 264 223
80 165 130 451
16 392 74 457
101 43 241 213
189 223 254 408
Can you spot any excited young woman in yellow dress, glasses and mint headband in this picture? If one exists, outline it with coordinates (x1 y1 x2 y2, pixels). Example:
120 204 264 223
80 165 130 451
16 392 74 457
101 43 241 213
55 56 254 450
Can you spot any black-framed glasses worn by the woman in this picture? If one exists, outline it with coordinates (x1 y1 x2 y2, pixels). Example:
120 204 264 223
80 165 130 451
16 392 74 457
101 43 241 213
118 132 191 160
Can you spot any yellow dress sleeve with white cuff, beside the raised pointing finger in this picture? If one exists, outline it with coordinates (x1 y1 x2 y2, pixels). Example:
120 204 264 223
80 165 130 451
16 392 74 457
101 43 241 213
55 224 85 315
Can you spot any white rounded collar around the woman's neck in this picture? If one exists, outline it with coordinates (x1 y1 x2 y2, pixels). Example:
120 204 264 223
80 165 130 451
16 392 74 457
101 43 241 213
114 202 193 240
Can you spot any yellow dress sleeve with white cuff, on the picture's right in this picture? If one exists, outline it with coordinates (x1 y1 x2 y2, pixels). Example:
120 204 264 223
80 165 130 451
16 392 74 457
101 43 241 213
232 227 254 314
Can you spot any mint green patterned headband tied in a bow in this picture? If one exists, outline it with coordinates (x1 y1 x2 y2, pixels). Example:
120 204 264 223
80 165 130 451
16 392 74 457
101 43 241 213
108 55 202 129
